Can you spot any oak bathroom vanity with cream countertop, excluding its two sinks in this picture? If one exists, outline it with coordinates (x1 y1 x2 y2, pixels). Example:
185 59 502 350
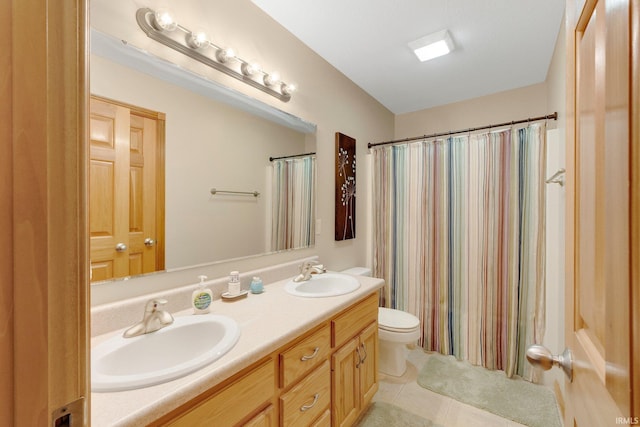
91 277 384 426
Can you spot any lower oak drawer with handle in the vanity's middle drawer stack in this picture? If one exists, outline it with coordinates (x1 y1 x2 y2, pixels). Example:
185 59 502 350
280 360 331 426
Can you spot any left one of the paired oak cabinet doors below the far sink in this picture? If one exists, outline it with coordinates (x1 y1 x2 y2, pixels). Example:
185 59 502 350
331 337 360 427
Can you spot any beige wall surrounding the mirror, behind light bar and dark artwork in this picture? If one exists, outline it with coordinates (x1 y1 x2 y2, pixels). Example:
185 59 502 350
91 0 394 304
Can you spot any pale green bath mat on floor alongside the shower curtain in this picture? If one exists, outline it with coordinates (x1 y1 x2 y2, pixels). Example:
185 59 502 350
418 354 562 427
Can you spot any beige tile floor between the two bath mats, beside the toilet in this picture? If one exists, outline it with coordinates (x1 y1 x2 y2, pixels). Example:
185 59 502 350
373 348 523 427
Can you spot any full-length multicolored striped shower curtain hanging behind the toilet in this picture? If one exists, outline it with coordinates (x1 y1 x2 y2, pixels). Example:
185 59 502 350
373 123 546 379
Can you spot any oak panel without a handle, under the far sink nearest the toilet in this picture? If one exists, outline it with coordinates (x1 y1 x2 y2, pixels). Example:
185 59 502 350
331 292 378 348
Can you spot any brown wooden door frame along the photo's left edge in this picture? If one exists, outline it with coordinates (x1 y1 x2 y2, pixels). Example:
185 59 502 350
0 0 90 426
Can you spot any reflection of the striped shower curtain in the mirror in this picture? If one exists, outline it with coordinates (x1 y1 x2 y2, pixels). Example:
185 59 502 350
271 156 316 251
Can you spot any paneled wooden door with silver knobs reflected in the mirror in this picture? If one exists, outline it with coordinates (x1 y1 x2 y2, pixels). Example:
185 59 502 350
89 97 164 281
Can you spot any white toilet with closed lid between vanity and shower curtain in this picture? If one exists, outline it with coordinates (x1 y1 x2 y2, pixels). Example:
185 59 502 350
343 267 420 377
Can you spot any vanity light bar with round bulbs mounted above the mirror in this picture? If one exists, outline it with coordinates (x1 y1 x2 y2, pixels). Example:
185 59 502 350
136 7 296 102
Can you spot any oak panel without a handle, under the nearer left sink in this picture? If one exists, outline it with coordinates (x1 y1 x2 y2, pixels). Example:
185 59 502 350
169 359 275 427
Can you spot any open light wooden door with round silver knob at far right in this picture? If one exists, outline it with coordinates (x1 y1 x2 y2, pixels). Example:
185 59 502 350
565 0 640 426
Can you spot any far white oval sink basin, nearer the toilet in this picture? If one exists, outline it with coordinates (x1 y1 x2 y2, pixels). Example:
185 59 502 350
284 273 360 298
